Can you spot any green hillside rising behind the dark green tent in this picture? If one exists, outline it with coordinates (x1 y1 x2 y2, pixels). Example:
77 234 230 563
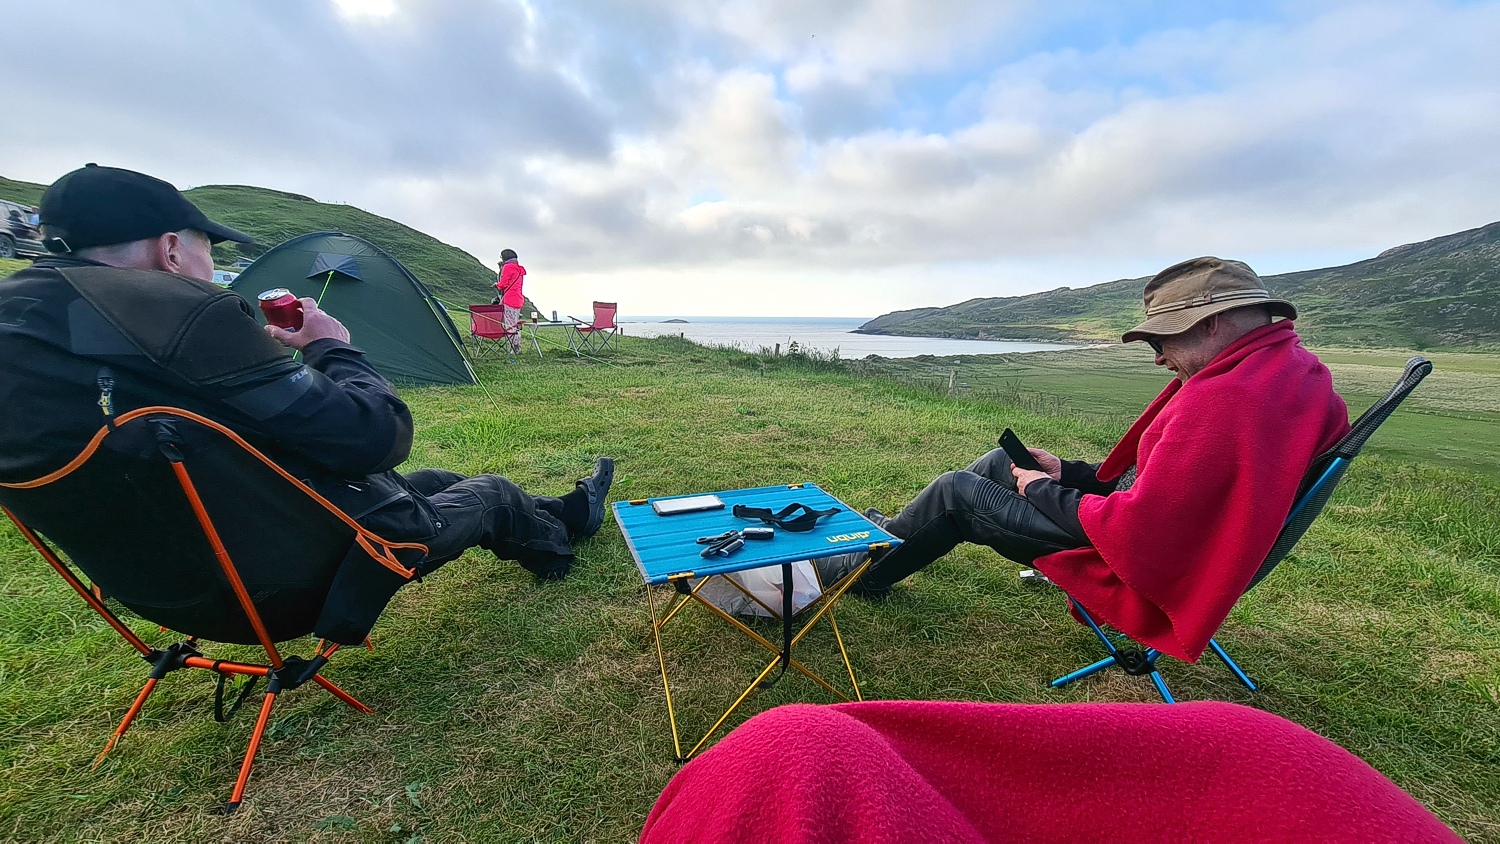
0 177 531 309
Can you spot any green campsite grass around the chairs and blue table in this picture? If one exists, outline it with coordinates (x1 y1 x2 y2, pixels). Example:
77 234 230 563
0 339 1500 843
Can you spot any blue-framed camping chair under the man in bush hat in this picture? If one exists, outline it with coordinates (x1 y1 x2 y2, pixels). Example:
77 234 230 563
1050 357 1433 703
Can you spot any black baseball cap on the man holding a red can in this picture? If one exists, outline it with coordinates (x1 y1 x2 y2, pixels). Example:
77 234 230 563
42 163 254 255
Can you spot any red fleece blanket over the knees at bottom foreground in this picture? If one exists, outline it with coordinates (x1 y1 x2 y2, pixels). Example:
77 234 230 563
641 700 1460 844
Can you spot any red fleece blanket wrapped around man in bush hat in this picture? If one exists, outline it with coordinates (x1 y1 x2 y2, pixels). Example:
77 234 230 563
1035 321 1349 661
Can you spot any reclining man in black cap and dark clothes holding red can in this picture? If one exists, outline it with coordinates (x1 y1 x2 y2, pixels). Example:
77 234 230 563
0 165 614 593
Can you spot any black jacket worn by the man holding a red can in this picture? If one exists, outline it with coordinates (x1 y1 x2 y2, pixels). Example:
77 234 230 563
0 258 426 527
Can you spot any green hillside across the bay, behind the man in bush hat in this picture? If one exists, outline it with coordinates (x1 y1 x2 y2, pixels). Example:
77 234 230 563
860 223 1500 349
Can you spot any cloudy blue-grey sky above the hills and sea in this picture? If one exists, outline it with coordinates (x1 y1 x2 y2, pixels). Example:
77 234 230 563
0 0 1500 318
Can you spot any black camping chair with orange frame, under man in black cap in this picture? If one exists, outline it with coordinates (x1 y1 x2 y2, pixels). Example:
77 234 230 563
0 408 428 813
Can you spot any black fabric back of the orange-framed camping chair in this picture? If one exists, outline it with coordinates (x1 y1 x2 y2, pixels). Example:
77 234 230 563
0 415 354 645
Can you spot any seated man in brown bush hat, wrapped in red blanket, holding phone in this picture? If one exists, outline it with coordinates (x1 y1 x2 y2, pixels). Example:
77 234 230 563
857 258 1349 660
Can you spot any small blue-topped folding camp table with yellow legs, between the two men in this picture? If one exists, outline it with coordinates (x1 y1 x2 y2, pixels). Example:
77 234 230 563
614 484 900 762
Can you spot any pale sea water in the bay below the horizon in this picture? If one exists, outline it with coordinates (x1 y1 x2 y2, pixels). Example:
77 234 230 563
620 316 1073 358
